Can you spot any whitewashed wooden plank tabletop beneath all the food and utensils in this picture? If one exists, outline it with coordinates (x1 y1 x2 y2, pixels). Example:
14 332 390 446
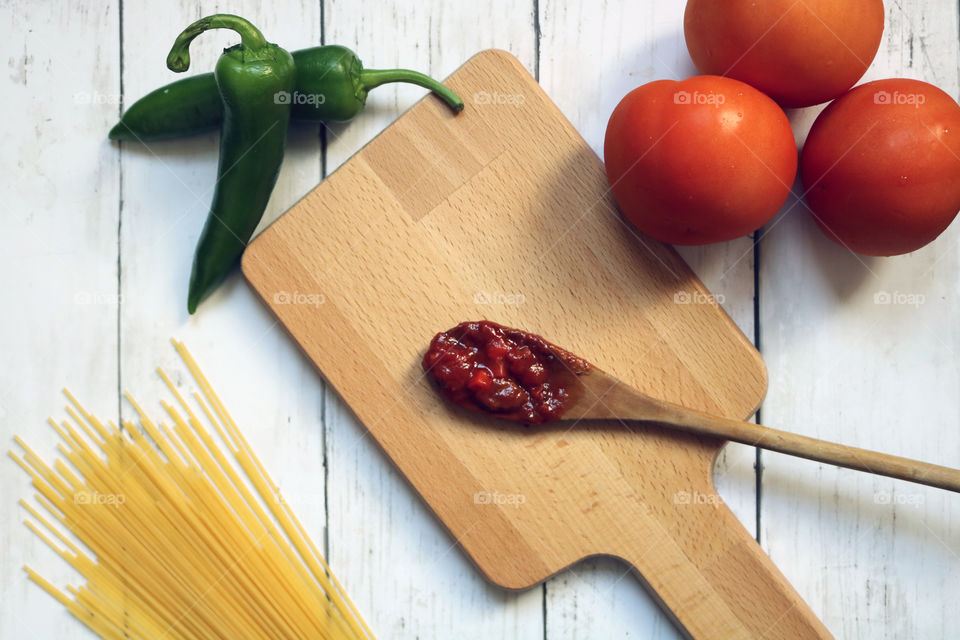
0 0 960 640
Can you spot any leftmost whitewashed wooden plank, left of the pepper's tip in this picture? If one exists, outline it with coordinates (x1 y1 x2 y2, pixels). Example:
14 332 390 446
0 2 120 638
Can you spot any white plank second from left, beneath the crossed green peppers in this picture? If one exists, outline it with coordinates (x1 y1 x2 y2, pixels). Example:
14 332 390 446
121 0 330 616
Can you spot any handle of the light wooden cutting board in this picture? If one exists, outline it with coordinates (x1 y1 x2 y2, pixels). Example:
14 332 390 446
617 496 833 639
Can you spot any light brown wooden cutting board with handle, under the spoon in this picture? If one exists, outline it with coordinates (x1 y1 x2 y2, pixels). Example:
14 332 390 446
243 51 829 638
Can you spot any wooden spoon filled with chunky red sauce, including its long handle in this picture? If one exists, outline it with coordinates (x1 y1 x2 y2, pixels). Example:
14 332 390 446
422 320 960 492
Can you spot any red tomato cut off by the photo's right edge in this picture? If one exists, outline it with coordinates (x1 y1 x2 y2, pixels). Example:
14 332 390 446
801 78 960 256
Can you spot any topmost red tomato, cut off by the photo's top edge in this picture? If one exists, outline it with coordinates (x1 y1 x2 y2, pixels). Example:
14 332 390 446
683 0 883 107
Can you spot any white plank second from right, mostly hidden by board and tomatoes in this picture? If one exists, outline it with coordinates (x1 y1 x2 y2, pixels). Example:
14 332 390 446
539 0 756 638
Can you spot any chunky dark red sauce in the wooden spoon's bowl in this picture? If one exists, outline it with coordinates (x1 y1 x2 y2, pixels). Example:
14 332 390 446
421 320 590 424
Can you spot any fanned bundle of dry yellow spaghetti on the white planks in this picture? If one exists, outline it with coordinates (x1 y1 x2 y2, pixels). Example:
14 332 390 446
10 341 373 639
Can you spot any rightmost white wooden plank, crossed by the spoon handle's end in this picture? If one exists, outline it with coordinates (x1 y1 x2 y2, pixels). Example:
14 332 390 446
760 0 960 639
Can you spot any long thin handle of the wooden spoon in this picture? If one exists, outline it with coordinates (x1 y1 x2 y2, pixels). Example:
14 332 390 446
655 404 960 492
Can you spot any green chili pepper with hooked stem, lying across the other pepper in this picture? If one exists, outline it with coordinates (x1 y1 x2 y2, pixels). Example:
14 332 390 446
167 14 296 313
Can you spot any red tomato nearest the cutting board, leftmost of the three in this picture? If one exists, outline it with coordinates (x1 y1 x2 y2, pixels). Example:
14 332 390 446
603 76 797 244
